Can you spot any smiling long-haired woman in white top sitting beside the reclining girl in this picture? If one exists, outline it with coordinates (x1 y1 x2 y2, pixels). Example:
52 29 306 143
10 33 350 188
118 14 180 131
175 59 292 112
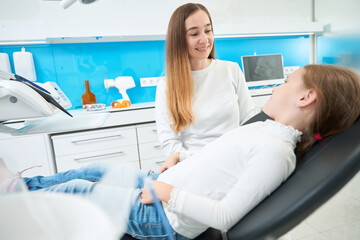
156 3 255 172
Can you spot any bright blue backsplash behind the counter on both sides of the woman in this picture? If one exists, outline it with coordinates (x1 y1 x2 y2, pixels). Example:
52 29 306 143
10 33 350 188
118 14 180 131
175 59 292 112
0 36 309 109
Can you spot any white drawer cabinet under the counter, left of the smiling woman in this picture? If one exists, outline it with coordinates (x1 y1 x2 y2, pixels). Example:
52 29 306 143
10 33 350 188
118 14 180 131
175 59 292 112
51 123 165 172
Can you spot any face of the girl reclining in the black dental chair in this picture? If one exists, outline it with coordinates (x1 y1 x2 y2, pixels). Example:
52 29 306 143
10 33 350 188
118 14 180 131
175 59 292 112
263 68 307 119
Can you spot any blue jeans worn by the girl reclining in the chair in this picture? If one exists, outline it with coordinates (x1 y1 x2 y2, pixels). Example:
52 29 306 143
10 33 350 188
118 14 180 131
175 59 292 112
24 163 188 240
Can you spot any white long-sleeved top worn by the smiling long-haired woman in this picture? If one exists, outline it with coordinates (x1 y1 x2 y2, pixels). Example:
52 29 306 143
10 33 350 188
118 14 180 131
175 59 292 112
155 60 255 157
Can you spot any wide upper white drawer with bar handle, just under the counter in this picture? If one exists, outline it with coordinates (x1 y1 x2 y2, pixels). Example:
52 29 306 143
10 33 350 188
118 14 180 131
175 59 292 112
52 127 137 156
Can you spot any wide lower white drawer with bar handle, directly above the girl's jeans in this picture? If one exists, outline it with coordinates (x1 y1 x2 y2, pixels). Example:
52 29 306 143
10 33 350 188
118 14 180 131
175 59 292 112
56 145 139 172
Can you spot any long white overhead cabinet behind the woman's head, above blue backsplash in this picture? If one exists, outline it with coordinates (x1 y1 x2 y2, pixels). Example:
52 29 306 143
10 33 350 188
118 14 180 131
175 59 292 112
36 0 323 43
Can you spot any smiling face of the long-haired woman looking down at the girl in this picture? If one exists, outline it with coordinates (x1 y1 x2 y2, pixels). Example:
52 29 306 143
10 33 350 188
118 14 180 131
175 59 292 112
185 10 214 62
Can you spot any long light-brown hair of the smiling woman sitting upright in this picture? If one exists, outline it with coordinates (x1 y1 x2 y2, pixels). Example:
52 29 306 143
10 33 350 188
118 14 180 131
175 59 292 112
166 3 215 132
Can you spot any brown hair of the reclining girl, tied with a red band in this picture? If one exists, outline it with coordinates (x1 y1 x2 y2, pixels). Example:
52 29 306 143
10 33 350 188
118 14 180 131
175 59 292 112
296 64 360 157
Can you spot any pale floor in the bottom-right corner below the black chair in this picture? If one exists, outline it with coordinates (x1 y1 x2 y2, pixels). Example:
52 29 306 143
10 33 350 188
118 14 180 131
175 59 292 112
279 172 360 240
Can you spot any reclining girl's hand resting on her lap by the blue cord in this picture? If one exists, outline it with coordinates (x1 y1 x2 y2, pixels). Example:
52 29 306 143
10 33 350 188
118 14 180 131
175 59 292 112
141 181 174 204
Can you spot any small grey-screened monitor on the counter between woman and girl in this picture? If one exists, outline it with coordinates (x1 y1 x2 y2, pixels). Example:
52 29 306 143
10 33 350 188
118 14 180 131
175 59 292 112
241 54 285 87
